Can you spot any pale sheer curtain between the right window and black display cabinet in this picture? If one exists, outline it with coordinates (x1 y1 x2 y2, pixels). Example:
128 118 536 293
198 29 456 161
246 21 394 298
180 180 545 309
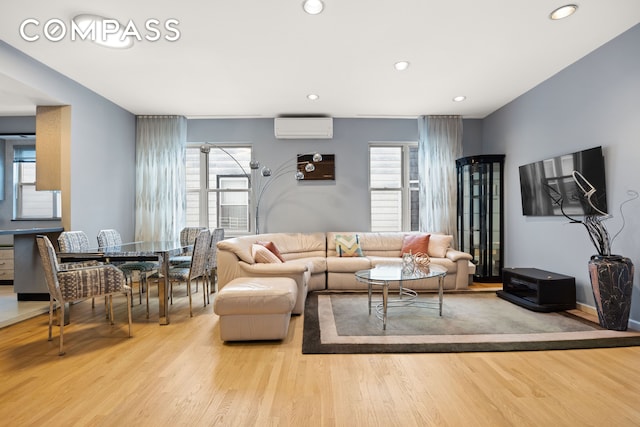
418 116 462 245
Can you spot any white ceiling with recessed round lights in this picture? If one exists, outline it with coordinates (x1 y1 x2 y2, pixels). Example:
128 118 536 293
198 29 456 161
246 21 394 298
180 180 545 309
0 0 640 118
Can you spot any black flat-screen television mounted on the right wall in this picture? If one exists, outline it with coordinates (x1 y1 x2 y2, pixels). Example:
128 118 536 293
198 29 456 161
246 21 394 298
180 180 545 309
519 147 608 216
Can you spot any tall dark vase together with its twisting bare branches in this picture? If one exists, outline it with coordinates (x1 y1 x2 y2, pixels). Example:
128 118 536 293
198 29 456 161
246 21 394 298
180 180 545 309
550 171 638 331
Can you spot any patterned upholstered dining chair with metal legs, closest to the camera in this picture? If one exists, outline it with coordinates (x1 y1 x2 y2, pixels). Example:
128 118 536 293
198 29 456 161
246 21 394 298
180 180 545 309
36 235 131 356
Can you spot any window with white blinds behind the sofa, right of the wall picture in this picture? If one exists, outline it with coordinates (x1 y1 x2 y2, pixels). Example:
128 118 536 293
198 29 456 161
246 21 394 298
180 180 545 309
369 143 420 231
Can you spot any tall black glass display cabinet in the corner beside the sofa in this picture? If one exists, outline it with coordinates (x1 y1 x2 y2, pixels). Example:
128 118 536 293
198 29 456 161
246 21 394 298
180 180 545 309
456 154 504 282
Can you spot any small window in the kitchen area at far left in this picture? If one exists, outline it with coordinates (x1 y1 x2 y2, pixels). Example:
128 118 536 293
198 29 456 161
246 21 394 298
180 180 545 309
13 145 62 219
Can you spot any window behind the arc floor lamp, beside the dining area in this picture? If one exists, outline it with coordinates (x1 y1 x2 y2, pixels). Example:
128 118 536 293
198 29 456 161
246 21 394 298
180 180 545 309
186 144 251 234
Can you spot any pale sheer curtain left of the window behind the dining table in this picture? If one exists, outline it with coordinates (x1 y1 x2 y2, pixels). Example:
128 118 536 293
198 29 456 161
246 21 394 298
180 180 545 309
135 116 187 241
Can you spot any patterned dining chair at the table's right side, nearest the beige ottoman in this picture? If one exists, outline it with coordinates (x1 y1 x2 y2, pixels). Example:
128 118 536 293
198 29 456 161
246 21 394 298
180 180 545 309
147 228 211 317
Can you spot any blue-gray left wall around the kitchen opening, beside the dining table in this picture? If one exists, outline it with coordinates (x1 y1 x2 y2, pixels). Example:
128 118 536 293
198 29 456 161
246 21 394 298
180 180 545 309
0 41 135 244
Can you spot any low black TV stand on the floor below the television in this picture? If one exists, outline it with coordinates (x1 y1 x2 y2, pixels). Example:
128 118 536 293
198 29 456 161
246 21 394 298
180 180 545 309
496 268 576 312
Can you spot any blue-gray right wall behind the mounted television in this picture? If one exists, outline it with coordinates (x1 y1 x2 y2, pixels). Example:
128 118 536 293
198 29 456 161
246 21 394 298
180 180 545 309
483 25 640 321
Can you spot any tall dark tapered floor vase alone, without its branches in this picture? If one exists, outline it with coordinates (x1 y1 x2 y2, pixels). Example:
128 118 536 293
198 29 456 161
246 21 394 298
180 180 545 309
589 255 633 331
